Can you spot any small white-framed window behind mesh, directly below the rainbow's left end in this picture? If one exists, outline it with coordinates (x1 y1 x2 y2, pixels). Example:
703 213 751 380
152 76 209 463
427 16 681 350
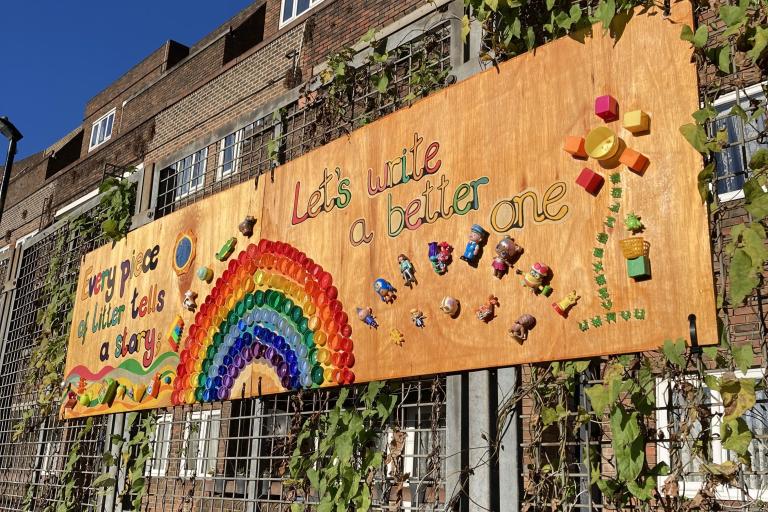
179 411 221 477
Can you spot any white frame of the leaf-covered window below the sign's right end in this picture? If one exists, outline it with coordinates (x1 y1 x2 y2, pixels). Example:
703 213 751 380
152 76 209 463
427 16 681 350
656 368 768 501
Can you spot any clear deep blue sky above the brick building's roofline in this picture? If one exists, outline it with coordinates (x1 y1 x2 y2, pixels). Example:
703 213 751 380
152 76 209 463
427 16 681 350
0 0 253 160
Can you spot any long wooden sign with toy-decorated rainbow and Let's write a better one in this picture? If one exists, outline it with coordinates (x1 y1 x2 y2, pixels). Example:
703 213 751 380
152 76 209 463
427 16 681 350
64 4 717 417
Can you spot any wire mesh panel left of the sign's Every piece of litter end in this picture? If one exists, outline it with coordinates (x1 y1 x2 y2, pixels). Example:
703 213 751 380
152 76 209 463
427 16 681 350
0 206 106 510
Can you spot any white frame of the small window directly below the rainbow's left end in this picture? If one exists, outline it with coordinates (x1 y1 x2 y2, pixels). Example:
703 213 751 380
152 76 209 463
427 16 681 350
179 410 221 478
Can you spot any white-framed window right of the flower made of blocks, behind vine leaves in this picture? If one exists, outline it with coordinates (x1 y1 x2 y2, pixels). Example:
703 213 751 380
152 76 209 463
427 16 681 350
712 84 766 201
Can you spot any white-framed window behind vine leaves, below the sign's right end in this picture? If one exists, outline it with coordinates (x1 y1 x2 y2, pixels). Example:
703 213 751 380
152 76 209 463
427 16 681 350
656 368 768 501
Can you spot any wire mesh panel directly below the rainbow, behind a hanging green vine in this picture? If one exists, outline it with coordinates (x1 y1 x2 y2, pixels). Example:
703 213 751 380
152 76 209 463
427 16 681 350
144 377 445 511
